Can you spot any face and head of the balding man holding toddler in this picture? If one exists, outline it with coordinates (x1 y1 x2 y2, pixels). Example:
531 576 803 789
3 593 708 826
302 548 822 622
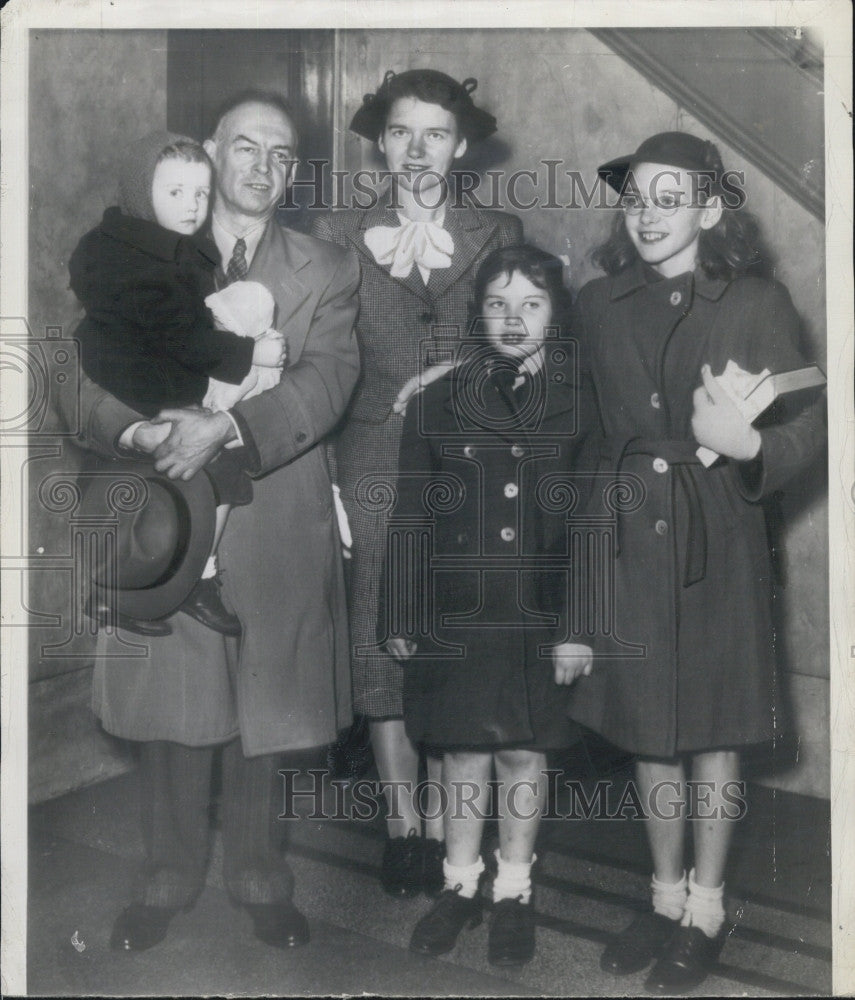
205 103 297 219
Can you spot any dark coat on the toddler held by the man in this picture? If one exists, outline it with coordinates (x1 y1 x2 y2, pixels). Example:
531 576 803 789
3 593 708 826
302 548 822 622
69 208 255 417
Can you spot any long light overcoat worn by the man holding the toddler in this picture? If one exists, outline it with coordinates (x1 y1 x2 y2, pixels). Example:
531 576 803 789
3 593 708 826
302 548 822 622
68 215 359 756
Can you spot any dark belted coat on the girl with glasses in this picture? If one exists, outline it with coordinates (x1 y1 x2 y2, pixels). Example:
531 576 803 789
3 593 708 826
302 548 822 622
570 262 825 757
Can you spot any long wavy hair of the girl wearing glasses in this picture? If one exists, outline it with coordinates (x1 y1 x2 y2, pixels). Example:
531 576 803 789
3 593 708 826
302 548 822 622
591 135 771 281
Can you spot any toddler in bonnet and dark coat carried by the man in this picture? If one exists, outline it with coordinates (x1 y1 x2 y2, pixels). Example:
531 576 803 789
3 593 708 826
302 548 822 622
69 132 285 635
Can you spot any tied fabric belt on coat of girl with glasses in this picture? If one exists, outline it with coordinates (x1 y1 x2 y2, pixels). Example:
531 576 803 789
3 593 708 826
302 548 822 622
600 437 707 587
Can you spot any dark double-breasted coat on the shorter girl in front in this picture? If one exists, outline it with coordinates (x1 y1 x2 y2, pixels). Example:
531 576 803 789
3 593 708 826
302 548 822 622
390 354 596 749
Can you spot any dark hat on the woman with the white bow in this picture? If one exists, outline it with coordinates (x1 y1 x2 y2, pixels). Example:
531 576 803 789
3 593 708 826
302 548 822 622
350 69 496 142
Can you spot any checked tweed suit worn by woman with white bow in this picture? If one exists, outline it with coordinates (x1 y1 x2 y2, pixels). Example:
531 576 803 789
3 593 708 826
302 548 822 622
313 204 522 718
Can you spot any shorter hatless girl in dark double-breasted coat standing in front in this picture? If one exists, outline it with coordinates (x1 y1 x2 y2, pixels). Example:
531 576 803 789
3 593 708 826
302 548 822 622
381 246 595 965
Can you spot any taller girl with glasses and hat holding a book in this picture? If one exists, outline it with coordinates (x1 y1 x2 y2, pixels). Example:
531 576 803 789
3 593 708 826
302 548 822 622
570 132 824 994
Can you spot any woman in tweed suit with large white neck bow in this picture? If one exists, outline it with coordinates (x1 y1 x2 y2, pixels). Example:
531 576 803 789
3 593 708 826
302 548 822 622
313 69 522 895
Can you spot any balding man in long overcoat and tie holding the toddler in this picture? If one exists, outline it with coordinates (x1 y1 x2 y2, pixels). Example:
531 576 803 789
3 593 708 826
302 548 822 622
67 92 359 951
